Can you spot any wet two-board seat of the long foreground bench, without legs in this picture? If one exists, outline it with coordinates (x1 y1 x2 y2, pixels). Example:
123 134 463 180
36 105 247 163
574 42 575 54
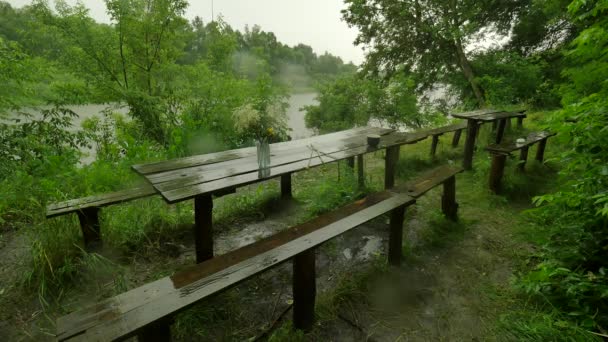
57 192 415 341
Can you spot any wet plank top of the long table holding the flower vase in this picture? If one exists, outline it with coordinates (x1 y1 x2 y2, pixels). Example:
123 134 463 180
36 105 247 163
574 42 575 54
133 127 428 203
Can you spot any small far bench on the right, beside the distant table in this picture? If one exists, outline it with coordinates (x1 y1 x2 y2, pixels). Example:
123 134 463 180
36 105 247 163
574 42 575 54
486 131 556 193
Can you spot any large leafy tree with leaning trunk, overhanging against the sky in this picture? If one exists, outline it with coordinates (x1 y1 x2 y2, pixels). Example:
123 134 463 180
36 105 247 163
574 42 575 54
342 0 524 107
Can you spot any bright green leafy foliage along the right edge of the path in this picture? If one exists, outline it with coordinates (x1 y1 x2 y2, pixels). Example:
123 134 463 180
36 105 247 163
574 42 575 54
522 0 608 331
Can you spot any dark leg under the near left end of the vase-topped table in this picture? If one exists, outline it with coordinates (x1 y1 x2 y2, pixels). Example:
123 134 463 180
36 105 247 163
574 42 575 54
194 195 213 263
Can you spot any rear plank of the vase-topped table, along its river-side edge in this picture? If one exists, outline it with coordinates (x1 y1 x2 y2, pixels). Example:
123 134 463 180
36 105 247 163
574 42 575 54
132 127 377 175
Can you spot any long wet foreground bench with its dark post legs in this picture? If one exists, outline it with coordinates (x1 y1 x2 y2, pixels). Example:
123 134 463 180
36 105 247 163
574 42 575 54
56 191 415 341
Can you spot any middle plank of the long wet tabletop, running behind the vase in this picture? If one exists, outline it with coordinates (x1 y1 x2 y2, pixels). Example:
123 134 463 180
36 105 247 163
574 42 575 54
145 129 391 188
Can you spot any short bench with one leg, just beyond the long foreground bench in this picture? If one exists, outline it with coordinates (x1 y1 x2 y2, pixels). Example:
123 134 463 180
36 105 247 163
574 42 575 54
396 165 464 221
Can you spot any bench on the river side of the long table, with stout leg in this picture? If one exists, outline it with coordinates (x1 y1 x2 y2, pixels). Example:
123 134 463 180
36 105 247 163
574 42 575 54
46 185 235 250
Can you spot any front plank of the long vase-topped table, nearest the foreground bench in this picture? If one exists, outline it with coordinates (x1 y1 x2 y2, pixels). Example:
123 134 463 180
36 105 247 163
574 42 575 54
155 132 427 203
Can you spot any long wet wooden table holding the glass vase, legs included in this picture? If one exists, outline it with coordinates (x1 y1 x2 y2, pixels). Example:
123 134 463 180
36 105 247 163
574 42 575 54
132 127 428 263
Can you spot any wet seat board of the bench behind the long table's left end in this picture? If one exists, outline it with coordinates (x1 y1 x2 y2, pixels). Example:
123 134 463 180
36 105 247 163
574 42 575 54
46 185 156 218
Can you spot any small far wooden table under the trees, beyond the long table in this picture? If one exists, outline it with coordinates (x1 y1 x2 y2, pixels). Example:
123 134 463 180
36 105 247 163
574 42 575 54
452 109 526 170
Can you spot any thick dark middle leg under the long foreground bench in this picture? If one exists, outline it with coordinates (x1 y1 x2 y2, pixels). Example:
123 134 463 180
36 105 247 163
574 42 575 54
293 248 317 331
